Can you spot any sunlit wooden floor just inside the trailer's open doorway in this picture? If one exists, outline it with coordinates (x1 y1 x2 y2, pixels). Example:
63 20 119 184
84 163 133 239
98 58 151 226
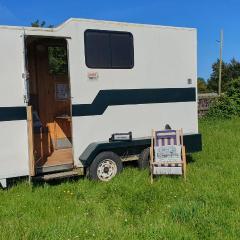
36 148 73 167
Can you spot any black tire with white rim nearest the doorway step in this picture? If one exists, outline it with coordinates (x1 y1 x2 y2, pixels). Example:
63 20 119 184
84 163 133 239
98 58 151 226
87 152 123 181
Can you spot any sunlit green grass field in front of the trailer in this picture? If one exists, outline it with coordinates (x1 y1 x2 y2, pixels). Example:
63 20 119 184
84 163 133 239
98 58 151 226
0 119 240 240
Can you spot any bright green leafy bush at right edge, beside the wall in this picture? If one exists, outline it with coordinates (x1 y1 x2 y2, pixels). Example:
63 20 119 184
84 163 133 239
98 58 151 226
206 78 240 118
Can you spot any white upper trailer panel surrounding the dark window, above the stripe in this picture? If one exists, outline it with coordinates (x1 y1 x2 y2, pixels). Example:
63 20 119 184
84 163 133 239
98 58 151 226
69 23 197 104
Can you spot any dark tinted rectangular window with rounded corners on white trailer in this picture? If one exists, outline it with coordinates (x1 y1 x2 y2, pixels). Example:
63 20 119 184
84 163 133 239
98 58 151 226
85 30 134 69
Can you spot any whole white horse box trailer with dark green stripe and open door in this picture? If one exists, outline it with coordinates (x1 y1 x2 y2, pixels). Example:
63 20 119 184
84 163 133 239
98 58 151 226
0 19 201 187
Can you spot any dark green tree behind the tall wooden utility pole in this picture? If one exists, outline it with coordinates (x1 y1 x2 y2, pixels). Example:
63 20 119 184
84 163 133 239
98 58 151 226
208 58 240 92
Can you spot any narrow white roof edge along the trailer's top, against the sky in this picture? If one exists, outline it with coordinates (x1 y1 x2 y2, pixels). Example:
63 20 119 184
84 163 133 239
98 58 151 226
0 18 196 32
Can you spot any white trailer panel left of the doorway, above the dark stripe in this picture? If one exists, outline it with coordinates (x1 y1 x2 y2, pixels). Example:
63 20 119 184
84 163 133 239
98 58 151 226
0 30 24 107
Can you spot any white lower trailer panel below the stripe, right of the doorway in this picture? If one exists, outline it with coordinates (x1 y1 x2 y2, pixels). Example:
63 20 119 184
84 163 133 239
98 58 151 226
73 102 198 165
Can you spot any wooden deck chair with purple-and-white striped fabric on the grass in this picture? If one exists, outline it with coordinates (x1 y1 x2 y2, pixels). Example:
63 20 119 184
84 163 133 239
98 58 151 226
150 129 186 183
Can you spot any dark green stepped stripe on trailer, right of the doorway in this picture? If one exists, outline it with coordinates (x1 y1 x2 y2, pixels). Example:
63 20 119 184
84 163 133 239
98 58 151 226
72 88 196 116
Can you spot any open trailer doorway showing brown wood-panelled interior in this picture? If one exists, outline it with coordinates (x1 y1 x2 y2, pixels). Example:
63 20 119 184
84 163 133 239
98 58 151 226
26 37 73 174
